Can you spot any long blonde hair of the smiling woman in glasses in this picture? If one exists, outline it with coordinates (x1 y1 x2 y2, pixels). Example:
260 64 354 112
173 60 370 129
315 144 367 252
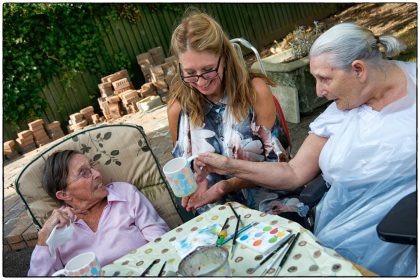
169 11 255 127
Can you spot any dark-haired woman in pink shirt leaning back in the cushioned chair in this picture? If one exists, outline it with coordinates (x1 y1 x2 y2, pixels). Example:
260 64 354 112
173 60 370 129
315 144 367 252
28 150 169 276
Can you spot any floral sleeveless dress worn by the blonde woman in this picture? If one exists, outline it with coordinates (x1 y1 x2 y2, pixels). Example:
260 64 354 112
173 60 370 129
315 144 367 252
172 97 289 213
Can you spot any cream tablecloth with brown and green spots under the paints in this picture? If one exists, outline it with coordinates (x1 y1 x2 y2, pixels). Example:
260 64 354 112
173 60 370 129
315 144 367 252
103 203 361 277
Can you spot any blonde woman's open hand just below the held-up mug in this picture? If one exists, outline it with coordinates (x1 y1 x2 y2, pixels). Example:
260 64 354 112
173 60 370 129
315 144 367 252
182 180 226 211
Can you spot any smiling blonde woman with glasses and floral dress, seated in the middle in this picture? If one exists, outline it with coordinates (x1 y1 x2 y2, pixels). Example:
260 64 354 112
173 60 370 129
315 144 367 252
168 11 296 221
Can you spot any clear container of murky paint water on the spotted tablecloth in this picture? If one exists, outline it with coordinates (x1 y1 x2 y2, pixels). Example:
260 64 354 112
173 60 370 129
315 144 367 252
177 246 232 277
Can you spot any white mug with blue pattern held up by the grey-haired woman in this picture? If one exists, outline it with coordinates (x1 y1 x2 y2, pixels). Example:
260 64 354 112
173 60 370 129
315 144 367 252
163 156 198 197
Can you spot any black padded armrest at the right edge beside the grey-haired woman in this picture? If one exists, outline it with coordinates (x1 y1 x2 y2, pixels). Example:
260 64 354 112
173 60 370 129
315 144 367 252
376 192 417 245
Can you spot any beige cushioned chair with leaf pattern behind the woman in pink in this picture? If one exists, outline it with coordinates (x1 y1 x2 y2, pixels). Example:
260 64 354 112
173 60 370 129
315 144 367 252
15 124 189 228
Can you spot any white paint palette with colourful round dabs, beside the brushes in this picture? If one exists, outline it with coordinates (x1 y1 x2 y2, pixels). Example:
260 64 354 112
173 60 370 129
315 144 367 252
236 223 291 254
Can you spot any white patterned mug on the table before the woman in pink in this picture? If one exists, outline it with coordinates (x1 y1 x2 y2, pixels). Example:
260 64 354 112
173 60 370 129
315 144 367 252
52 252 103 276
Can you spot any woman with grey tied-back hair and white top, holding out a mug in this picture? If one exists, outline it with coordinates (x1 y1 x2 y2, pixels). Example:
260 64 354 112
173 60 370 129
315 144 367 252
198 23 416 276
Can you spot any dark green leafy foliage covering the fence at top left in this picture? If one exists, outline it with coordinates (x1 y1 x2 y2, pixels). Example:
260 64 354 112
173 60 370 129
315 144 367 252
3 3 146 124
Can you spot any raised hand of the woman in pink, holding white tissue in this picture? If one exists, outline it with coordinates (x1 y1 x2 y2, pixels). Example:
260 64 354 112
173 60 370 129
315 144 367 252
37 206 75 246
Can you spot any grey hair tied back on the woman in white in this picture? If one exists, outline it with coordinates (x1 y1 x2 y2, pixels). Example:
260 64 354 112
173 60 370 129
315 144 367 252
309 22 406 69
